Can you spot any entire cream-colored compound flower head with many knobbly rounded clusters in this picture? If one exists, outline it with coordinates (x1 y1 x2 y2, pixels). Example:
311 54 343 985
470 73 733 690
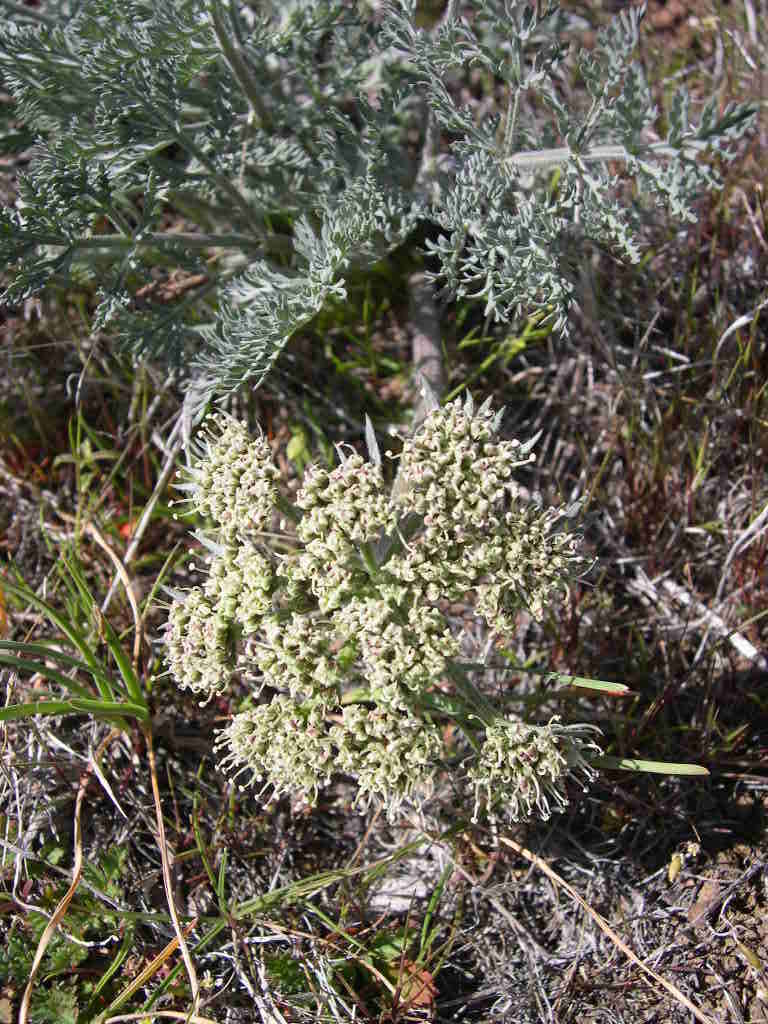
166 398 601 819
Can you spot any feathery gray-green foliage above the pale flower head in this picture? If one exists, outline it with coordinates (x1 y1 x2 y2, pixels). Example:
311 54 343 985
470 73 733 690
0 0 752 398
